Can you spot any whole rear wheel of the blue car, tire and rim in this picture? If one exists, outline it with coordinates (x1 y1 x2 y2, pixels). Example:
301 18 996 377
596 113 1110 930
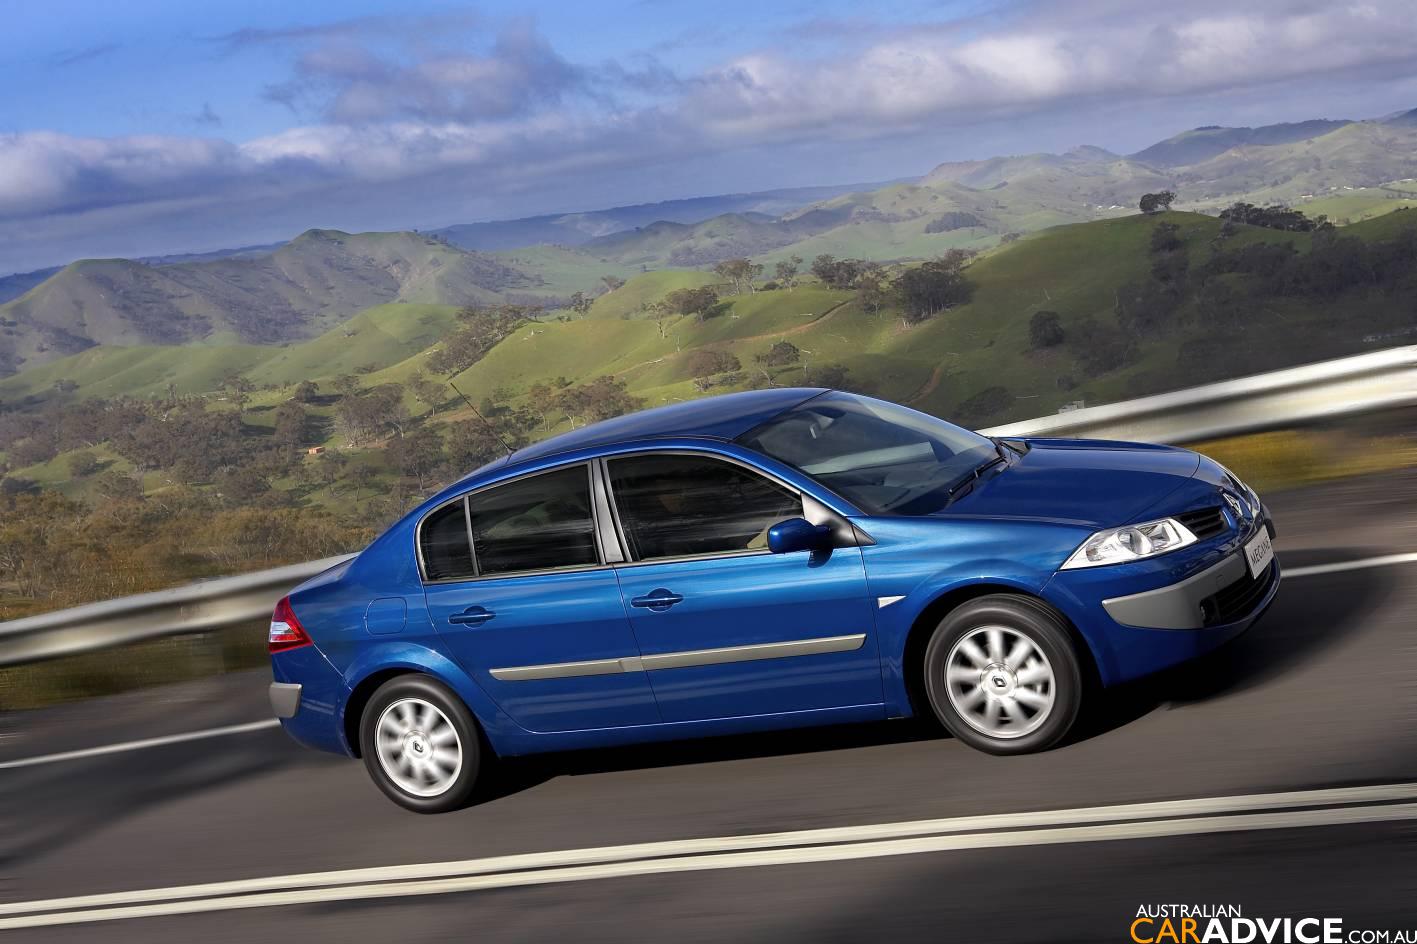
360 675 482 814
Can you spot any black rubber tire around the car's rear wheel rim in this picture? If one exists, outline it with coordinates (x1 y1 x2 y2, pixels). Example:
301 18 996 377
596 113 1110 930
359 675 483 814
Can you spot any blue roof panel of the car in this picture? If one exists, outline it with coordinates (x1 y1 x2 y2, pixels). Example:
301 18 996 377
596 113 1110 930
497 387 826 468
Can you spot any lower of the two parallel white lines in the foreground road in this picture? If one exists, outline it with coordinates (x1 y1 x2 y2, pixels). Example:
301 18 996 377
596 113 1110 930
0 804 1417 930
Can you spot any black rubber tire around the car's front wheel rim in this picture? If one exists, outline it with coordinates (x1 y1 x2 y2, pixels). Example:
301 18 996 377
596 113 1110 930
921 594 1083 754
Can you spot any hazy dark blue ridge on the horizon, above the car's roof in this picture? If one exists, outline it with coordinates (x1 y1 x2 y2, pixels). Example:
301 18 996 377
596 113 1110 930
431 183 886 249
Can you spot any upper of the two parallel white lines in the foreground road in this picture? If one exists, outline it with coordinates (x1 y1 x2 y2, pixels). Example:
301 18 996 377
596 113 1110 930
0 782 1417 916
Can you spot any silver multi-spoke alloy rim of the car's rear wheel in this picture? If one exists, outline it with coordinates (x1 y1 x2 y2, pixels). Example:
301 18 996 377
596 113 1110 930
374 697 462 797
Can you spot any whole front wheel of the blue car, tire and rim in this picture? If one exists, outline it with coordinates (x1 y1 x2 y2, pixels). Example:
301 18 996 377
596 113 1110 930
924 594 1083 754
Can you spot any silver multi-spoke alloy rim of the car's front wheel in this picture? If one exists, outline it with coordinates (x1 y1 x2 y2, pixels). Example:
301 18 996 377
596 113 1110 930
945 626 1057 738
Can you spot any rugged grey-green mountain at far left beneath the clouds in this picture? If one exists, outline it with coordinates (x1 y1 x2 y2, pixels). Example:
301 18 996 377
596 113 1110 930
0 230 540 373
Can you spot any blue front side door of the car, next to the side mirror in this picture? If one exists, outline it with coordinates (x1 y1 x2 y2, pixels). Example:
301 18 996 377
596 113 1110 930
605 452 881 721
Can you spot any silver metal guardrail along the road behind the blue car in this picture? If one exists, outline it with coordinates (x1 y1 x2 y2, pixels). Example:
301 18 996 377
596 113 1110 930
8 346 1417 666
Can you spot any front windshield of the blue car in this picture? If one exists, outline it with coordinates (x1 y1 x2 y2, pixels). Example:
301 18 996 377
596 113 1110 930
738 393 1000 515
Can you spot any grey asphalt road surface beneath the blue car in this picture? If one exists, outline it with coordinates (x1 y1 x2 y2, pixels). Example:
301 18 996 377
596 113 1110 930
0 476 1417 944
